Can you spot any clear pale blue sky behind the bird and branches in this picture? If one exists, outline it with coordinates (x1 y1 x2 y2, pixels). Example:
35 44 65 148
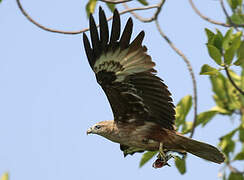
0 0 238 180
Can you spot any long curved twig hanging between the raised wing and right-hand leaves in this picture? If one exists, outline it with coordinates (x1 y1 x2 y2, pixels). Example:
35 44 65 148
155 19 197 138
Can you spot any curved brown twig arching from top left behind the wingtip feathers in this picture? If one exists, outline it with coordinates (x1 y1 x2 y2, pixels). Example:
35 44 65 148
16 0 158 35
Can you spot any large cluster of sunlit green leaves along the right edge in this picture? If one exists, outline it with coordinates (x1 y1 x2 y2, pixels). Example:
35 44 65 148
198 23 244 180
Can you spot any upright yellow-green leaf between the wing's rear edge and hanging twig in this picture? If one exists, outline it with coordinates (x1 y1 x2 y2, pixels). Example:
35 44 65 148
175 95 192 127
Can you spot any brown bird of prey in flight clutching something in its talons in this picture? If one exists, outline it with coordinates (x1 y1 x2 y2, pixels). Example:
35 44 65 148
83 7 224 167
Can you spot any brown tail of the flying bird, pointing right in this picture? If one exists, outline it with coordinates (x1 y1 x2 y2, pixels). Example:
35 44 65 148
173 134 225 164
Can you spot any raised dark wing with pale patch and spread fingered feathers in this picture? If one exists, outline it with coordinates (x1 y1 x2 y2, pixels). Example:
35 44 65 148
83 7 175 129
